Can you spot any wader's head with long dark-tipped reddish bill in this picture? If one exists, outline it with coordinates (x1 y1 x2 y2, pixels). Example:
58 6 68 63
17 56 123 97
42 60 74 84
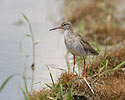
49 22 72 31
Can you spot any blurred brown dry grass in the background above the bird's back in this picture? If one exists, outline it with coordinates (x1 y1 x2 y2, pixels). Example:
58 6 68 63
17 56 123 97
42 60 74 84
64 0 125 45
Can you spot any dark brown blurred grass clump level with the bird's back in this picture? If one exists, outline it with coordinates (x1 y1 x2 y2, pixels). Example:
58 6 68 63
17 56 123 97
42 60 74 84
86 26 125 45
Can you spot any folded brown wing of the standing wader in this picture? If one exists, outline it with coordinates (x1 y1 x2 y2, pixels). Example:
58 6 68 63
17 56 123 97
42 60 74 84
76 34 98 55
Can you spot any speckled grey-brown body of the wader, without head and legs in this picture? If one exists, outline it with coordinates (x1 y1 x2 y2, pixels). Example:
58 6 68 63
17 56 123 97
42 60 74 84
64 29 98 56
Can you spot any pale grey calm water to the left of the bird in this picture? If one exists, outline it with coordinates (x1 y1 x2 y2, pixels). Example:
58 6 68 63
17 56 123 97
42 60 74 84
0 0 67 100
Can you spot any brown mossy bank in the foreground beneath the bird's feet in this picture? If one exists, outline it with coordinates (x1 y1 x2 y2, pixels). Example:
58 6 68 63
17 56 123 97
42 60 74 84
30 44 125 100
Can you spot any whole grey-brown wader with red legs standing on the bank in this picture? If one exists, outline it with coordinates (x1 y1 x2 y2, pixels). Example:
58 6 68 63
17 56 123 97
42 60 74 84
49 22 99 78
